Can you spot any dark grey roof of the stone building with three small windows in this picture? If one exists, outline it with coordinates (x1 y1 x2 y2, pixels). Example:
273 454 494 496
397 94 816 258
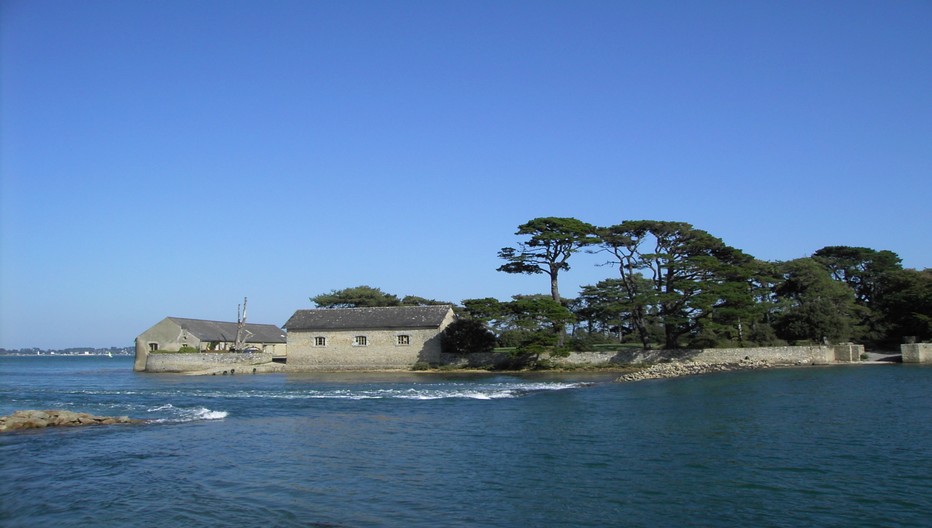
285 305 451 330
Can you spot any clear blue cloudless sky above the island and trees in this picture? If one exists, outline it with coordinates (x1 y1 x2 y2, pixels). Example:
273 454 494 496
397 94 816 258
0 0 932 348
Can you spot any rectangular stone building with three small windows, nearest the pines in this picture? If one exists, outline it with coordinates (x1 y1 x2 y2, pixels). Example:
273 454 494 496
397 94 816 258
285 305 455 371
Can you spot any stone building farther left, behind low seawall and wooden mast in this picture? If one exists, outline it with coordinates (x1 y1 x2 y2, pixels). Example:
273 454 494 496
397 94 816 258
135 317 287 370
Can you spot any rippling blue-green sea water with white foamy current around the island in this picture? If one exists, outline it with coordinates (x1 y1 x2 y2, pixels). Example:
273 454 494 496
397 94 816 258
0 356 932 528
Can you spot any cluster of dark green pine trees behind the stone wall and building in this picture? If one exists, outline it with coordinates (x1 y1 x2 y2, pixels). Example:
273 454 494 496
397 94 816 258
311 217 932 350
